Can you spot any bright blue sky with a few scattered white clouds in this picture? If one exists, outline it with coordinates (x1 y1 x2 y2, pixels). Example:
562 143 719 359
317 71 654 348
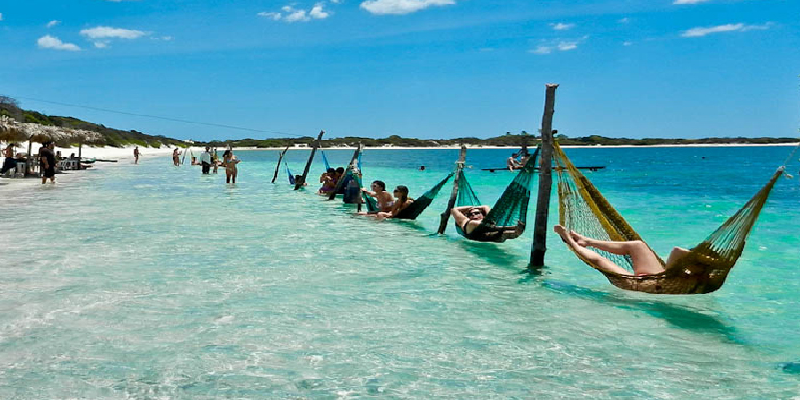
0 0 800 140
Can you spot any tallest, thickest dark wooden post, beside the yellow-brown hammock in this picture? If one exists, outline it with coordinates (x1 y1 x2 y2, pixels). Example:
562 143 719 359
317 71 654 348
530 84 558 267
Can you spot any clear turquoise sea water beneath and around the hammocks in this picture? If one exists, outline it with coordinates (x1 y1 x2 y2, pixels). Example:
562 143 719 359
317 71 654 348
0 147 800 399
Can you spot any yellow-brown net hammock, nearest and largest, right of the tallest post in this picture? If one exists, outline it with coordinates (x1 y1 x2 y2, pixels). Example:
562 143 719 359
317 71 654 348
554 143 783 294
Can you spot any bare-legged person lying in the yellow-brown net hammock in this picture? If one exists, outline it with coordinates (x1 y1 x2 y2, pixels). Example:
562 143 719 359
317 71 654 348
553 225 689 276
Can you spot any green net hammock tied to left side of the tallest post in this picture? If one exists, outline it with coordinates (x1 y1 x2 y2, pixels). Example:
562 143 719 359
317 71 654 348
456 147 539 243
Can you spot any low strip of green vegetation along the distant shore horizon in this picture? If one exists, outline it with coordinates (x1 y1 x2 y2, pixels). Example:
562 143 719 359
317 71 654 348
0 96 797 148
